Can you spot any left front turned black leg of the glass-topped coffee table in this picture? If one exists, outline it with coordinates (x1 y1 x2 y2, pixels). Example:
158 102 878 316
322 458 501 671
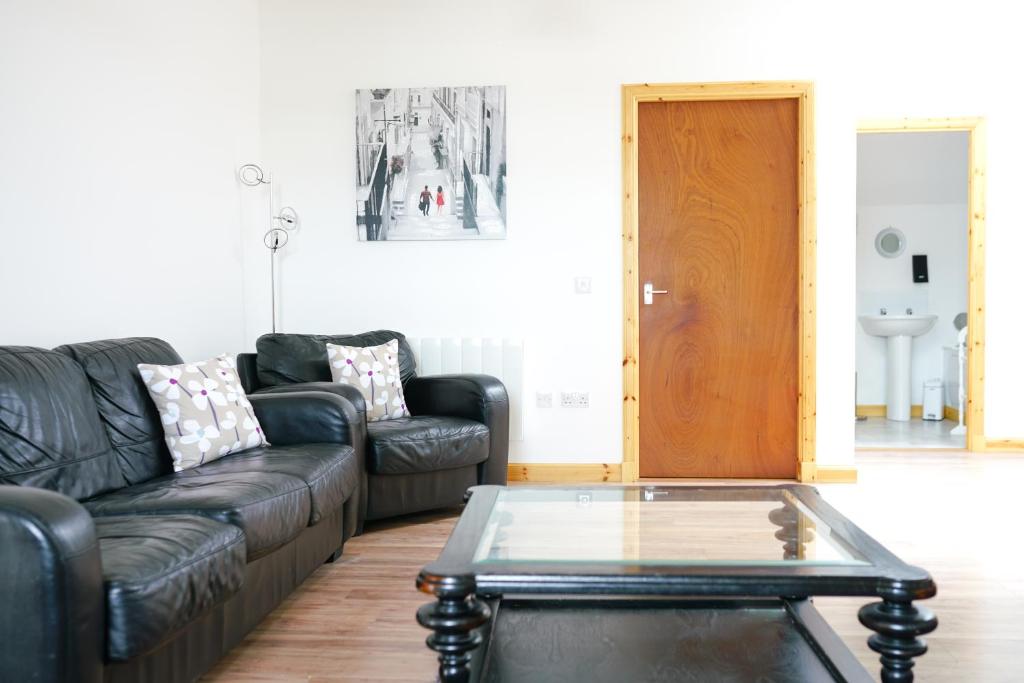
416 575 490 683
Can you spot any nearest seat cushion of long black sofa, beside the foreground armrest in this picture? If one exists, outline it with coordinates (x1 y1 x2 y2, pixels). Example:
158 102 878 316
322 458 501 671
95 515 246 660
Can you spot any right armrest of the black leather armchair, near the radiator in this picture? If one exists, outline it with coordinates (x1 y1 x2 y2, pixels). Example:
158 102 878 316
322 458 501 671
402 375 509 484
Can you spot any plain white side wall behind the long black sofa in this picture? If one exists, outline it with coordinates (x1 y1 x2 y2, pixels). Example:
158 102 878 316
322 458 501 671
0 0 259 358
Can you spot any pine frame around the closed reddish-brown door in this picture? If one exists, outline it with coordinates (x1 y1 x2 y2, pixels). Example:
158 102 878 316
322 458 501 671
622 81 817 482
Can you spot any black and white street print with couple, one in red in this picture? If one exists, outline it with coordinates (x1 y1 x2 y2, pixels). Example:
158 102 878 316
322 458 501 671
355 85 508 242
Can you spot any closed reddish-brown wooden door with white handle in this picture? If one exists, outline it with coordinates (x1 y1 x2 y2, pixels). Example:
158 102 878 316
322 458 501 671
637 99 800 478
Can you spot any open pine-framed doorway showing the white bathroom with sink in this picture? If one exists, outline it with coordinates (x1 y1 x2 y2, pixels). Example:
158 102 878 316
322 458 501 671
855 119 984 450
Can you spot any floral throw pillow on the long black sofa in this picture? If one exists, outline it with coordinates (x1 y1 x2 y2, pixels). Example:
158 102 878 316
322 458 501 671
138 355 269 472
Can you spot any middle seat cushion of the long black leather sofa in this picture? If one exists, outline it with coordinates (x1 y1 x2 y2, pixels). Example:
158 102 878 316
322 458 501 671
83 472 310 560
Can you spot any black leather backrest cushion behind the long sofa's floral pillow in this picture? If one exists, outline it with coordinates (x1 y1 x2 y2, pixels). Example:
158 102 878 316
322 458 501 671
54 337 182 483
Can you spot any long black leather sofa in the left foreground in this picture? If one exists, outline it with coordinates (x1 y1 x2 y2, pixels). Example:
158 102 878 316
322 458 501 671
0 338 365 683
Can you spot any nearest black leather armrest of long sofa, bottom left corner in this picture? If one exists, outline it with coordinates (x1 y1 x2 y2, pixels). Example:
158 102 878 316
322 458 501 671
0 485 105 683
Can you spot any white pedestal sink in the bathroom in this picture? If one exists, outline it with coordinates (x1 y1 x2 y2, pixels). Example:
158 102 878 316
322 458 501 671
858 315 938 422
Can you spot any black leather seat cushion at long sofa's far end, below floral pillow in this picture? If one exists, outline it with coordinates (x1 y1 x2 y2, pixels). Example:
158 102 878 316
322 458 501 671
178 443 359 526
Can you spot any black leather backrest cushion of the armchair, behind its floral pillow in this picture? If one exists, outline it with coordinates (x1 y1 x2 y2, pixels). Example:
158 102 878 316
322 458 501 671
256 330 416 387
